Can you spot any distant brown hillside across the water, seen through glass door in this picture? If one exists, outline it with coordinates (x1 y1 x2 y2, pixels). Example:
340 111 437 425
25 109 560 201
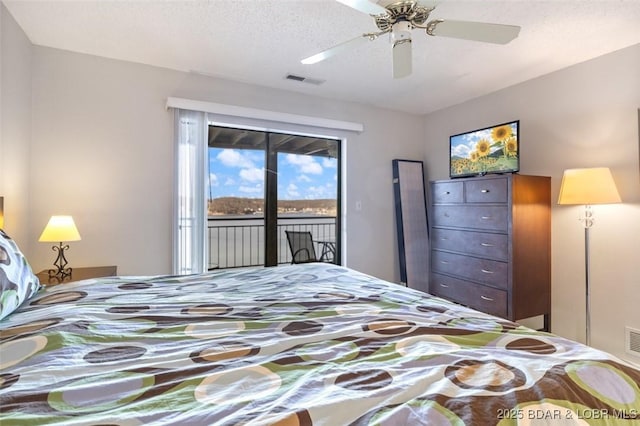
209 197 337 216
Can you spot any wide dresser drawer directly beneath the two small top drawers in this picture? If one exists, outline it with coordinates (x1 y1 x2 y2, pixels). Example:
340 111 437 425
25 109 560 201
433 205 509 232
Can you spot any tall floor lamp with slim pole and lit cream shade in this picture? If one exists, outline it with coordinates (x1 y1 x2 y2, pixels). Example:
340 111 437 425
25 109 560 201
558 167 622 345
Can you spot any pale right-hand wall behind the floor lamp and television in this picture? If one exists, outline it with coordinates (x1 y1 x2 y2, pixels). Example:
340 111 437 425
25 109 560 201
425 45 640 362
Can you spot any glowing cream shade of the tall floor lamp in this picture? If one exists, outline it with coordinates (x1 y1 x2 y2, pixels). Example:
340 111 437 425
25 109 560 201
558 167 622 204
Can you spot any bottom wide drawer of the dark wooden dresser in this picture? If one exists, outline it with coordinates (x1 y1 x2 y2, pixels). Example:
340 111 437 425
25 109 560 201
430 274 507 318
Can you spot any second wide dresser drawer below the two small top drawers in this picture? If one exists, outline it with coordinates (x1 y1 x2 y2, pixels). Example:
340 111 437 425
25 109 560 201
431 228 509 261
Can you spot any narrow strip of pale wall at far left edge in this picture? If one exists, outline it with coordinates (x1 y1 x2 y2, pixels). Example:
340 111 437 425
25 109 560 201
0 3 32 250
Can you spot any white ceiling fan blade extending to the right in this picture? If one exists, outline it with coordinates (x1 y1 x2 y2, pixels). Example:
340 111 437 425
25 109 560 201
427 19 520 44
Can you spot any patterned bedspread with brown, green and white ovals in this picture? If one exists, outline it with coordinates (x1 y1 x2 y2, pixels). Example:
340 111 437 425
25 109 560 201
0 264 640 426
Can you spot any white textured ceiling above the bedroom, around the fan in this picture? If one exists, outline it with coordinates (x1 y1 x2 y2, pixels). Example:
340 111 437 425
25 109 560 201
2 0 640 114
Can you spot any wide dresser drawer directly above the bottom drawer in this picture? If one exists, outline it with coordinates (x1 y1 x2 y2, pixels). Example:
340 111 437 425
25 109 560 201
431 250 509 289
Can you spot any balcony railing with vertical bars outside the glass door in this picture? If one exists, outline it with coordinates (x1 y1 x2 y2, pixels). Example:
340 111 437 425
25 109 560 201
207 216 336 269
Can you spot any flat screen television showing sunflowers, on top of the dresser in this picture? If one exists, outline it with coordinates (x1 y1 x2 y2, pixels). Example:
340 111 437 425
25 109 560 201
449 120 520 178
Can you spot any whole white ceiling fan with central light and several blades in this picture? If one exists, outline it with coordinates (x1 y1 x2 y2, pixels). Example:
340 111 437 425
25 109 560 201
301 0 520 78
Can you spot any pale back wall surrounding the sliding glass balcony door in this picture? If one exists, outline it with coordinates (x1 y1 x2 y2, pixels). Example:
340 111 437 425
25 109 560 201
28 47 424 280
